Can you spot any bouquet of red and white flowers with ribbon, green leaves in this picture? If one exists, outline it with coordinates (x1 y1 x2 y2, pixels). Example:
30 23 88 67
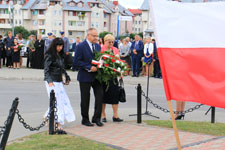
92 51 128 89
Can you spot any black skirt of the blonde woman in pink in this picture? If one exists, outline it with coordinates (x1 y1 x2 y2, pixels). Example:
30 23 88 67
103 78 119 104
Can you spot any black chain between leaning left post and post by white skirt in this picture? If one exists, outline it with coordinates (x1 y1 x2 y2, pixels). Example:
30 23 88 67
16 105 58 131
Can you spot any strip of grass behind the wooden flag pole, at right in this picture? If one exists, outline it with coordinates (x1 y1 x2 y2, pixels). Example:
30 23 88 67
145 120 225 136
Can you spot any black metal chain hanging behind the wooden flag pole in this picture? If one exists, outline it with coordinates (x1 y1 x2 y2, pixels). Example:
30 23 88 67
139 88 204 114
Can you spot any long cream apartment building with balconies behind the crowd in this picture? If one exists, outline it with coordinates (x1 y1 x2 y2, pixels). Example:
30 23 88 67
0 0 133 39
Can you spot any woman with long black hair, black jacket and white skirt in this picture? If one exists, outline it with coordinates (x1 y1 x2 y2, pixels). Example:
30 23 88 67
44 38 75 129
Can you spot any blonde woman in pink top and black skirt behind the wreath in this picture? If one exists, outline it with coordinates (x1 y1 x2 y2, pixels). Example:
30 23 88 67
101 34 123 122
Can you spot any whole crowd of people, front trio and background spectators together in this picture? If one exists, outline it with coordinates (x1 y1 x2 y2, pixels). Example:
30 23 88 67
0 28 184 127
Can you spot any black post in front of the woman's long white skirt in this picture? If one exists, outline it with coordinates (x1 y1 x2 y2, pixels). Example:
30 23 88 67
49 90 55 135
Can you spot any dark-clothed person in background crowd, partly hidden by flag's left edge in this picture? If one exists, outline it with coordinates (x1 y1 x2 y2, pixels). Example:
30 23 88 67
152 39 162 78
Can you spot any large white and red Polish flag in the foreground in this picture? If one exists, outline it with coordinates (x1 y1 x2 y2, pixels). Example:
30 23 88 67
150 0 225 108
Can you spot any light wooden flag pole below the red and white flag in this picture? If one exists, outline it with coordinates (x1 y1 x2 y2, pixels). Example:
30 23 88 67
168 101 181 150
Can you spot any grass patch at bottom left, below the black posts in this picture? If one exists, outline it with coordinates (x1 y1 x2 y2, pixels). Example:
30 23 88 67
6 132 113 150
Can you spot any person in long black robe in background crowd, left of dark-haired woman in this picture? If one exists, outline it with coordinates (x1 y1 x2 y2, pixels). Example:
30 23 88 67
34 35 45 69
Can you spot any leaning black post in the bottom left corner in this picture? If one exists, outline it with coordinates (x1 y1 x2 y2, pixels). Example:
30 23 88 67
0 98 19 150
